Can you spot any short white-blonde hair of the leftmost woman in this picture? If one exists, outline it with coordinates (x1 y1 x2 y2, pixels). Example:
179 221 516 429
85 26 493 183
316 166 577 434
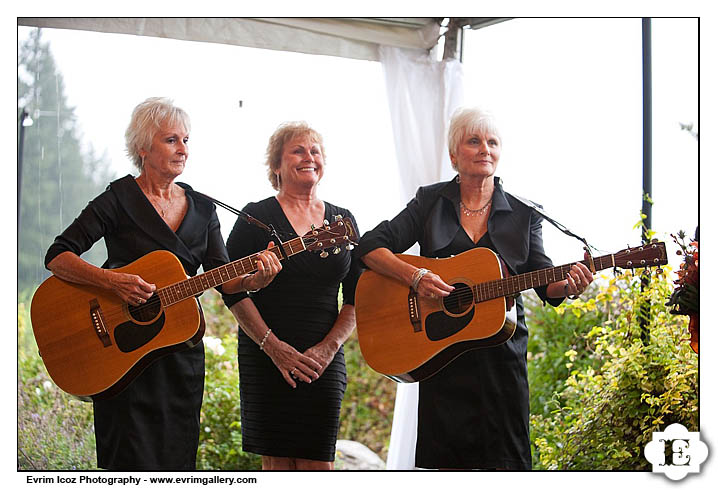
125 97 190 172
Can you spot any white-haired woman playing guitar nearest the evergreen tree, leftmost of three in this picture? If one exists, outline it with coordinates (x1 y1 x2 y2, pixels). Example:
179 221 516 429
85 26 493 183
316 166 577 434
45 98 281 471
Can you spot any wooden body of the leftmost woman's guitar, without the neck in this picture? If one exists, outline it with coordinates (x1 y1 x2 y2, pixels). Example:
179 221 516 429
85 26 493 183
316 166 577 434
31 250 204 399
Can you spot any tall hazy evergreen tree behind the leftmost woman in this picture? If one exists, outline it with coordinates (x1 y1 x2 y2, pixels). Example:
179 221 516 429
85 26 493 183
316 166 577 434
17 29 112 295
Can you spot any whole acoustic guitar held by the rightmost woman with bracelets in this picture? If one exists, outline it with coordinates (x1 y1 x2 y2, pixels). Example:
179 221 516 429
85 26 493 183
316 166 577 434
355 242 668 383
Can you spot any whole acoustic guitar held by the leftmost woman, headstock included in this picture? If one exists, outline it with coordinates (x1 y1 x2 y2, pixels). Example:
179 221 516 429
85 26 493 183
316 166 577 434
30 216 357 399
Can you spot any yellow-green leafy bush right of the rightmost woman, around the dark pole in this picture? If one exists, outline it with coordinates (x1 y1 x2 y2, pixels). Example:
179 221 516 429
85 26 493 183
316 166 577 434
531 274 698 470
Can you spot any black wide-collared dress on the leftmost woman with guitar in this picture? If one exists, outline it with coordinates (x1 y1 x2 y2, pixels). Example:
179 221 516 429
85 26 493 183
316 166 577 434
45 175 228 471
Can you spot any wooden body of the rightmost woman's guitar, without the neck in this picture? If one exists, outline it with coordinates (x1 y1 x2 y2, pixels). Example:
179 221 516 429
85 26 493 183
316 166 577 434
355 248 516 382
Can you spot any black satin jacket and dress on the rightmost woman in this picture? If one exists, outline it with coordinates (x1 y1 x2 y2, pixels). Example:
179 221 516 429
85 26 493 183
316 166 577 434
356 179 561 470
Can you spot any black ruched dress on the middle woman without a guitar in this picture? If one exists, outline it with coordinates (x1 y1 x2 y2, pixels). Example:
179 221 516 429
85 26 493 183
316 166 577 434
225 197 360 461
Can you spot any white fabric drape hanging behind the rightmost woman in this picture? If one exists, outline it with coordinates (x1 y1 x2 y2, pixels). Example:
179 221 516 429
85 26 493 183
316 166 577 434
379 46 463 470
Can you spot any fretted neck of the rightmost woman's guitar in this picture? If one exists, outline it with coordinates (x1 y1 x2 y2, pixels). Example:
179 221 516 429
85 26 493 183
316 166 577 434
472 254 616 303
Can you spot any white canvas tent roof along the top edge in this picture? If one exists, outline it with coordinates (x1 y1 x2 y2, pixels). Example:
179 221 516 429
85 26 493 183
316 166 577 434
18 17 506 61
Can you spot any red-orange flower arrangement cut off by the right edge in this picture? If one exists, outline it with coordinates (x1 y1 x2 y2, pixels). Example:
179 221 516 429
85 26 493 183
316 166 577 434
666 230 700 354
